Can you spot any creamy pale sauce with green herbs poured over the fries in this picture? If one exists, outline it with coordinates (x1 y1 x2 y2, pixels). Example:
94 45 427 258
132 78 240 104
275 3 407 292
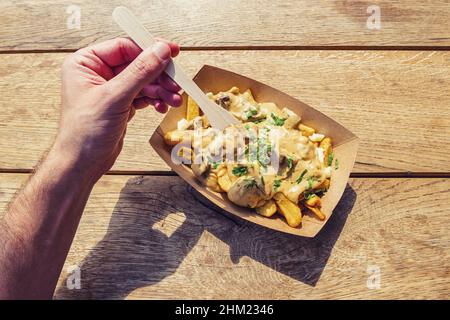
171 87 331 208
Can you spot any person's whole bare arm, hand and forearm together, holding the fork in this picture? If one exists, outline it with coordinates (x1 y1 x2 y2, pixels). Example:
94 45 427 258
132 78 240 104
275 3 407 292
0 39 181 299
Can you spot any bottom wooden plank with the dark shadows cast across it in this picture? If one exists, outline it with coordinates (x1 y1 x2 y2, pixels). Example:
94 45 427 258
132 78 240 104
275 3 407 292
0 174 450 299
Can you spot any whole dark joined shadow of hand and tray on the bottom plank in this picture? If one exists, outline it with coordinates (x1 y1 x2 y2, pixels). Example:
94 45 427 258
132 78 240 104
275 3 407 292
55 177 356 299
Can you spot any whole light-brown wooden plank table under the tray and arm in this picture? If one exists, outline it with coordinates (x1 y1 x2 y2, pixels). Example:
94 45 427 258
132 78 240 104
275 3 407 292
0 0 450 299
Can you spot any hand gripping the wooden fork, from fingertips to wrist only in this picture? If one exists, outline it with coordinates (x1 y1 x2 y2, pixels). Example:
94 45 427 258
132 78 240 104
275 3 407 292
52 38 182 181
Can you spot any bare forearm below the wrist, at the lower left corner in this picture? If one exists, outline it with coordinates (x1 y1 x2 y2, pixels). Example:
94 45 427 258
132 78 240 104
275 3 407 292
0 147 95 299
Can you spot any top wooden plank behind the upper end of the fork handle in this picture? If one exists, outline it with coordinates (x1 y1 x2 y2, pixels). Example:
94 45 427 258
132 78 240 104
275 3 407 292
0 0 450 51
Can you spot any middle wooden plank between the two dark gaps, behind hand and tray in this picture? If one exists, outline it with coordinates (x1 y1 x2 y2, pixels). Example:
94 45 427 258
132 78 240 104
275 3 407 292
0 51 450 172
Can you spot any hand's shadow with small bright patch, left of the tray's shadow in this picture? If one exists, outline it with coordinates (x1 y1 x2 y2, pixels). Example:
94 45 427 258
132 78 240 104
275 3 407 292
55 177 203 299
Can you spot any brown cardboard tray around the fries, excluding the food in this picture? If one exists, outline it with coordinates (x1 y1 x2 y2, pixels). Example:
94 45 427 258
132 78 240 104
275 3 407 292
150 65 358 237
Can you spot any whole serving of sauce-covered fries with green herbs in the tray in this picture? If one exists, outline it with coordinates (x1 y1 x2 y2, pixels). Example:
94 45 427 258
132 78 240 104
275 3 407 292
164 87 334 228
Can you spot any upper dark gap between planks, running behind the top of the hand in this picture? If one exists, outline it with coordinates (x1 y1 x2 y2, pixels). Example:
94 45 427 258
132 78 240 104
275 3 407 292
0 46 450 54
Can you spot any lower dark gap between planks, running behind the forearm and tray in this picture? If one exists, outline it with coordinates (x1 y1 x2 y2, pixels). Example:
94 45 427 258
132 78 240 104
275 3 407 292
0 168 450 179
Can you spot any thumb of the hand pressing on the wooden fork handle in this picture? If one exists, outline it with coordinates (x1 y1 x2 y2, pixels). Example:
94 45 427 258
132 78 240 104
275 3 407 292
109 42 171 99
